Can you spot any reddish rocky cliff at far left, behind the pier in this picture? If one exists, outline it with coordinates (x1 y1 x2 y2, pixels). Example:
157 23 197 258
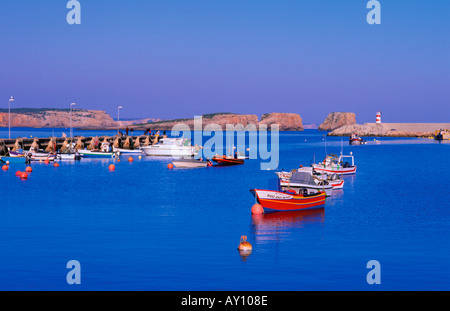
0 109 115 128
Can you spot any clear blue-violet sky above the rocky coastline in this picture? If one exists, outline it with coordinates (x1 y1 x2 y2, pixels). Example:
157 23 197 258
0 0 450 123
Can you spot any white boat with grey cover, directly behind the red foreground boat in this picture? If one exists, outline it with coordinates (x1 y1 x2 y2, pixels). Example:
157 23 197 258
275 170 333 196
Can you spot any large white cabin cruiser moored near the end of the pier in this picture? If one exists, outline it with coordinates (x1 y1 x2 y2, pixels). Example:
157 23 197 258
141 138 199 157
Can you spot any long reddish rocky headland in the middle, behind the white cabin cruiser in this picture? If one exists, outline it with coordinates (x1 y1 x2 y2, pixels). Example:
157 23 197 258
130 113 303 131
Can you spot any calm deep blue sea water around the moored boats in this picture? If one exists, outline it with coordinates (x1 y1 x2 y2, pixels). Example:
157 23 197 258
0 129 450 290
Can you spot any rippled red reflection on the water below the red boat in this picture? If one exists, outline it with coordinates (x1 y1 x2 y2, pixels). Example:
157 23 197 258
252 207 325 242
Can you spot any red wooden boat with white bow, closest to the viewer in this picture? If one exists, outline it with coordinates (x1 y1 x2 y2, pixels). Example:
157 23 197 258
250 189 325 212
